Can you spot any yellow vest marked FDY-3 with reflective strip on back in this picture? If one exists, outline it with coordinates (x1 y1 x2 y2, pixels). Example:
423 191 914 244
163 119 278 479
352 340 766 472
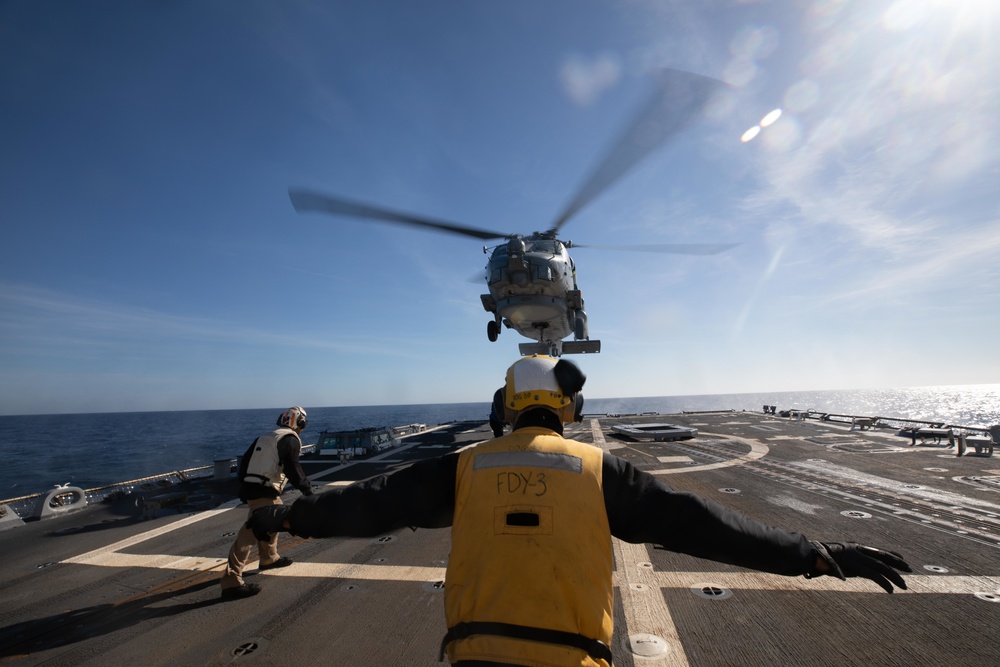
442 427 614 667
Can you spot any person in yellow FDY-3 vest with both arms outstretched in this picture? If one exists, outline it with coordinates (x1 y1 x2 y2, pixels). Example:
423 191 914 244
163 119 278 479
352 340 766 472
249 355 910 667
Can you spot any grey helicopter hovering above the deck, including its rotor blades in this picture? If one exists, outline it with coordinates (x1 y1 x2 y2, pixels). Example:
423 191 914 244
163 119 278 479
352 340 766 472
288 69 735 357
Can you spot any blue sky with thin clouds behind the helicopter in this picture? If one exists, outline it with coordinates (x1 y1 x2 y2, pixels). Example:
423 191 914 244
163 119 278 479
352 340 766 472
0 0 1000 414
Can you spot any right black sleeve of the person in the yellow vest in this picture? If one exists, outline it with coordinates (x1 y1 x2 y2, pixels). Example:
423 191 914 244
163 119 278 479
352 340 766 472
602 454 817 575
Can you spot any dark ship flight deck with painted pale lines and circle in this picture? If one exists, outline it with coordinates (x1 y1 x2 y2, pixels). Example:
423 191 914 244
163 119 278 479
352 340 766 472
0 412 1000 667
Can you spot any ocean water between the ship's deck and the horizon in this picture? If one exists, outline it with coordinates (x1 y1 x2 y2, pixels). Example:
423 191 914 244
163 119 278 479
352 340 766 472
0 384 1000 499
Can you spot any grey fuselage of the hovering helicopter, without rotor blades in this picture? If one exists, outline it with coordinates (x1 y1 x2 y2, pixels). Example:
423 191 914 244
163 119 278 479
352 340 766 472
480 233 589 345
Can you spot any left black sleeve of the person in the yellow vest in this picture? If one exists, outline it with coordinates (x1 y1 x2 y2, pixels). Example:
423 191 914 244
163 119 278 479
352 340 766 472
287 454 458 537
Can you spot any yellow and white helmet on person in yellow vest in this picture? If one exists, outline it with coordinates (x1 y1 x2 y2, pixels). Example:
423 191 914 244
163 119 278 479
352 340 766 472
504 354 586 423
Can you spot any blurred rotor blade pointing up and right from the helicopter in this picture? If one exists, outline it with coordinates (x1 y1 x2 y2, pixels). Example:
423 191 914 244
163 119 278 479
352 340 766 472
550 69 725 233
